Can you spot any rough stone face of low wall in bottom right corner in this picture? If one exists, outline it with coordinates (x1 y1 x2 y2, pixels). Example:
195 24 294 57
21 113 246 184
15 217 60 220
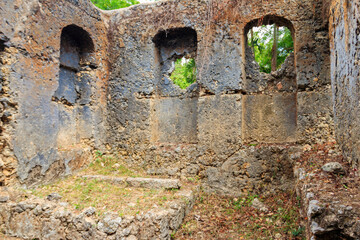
295 165 360 240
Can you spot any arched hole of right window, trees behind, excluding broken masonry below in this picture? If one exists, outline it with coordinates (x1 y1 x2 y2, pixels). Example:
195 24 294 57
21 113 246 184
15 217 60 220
245 16 294 73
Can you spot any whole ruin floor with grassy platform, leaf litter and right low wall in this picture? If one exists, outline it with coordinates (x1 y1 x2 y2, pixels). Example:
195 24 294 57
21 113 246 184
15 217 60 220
0 142 360 239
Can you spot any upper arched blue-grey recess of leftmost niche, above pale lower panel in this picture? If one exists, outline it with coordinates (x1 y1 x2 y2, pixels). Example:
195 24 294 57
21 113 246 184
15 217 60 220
53 25 96 106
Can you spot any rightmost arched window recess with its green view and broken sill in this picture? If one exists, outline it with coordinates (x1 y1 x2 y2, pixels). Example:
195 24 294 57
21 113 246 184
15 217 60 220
244 15 297 92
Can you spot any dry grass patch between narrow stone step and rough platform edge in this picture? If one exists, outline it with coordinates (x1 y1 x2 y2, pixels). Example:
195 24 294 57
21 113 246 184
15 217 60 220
32 176 179 216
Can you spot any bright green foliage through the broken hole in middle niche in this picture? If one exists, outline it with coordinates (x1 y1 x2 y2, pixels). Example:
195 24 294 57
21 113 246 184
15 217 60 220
170 57 196 89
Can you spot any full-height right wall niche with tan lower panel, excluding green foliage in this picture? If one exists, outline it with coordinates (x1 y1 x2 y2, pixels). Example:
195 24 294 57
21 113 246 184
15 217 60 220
242 16 297 143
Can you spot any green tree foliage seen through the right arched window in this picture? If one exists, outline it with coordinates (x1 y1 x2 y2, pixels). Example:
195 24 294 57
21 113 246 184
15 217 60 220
247 24 294 73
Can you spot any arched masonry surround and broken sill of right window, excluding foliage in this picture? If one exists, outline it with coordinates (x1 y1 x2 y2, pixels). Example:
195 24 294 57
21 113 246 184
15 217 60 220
243 15 297 94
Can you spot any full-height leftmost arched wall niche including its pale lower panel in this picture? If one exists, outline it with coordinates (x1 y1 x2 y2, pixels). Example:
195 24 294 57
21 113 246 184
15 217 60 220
52 25 96 147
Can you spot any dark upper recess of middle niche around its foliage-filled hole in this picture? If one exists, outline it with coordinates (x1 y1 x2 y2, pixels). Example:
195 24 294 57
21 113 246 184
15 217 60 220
153 27 197 96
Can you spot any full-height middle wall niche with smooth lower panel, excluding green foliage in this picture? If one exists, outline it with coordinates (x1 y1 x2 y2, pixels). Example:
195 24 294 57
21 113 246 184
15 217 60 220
152 28 198 144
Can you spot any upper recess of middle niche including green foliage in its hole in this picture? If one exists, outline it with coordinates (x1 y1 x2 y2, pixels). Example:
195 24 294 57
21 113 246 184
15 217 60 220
153 28 197 93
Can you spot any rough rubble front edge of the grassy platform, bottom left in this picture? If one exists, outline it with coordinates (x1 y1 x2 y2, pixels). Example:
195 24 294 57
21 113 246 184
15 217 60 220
0 190 197 240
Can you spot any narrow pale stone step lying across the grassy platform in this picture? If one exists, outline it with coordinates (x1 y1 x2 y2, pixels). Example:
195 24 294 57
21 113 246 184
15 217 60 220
80 175 181 189
